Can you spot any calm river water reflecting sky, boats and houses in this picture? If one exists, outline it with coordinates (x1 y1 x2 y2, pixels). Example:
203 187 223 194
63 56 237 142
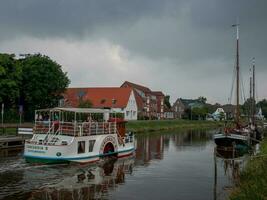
0 130 248 200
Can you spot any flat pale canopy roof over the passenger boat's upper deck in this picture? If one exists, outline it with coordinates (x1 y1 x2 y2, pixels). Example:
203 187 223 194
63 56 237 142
36 107 111 113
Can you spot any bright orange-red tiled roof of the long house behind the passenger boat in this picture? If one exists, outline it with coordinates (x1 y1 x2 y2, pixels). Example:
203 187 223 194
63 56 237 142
64 87 132 108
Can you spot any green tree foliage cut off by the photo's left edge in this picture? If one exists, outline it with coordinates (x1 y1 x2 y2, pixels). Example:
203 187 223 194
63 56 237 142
0 54 21 108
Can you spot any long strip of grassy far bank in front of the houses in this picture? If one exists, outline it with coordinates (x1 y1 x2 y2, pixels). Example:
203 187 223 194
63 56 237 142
126 120 223 133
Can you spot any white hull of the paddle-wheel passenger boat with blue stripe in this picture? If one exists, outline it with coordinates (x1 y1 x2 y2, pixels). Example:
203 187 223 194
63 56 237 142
24 134 136 164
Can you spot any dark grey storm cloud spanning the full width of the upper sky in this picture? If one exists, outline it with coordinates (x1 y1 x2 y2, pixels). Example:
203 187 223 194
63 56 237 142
0 0 267 69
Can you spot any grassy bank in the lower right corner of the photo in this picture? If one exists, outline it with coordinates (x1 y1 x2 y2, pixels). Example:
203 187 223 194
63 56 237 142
230 139 267 200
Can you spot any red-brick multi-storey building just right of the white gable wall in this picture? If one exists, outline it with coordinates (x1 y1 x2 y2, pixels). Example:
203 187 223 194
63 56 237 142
121 81 164 119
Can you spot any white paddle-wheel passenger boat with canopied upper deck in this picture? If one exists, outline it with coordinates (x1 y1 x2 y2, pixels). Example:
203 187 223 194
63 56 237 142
24 108 136 163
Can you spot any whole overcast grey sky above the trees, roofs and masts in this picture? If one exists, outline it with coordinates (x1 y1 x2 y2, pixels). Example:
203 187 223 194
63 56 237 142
0 0 267 103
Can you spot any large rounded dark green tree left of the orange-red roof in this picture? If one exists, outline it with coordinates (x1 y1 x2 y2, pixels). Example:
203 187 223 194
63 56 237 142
19 54 70 117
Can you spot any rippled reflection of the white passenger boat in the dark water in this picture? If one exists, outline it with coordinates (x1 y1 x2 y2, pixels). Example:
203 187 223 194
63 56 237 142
27 158 134 200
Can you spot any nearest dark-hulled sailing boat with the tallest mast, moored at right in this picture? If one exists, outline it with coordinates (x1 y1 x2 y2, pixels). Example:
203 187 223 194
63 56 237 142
214 24 251 147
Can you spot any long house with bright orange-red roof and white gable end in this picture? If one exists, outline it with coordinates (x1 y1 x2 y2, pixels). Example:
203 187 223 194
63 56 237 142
61 87 137 120
